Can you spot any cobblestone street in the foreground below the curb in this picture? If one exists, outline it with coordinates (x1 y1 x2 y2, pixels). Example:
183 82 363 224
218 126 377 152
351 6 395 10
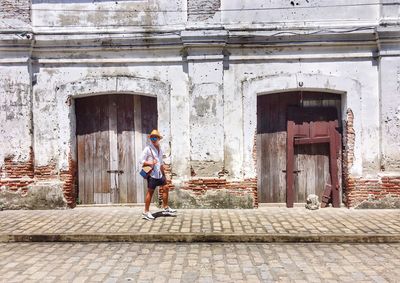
0 243 400 282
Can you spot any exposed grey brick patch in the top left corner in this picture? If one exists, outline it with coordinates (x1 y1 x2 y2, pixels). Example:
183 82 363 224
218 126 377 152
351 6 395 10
0 0 31 23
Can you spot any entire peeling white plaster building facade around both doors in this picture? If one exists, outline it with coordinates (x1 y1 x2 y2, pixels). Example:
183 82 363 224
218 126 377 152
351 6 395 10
0 0 400 207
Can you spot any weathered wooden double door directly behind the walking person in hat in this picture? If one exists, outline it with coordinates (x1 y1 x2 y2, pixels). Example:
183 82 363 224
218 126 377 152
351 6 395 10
75 94 157 204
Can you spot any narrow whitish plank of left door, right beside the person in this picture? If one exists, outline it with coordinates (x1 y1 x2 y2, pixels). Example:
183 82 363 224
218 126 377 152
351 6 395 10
132 95 146 203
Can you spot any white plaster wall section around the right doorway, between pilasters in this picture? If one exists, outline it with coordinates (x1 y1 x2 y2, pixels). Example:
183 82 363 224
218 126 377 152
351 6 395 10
224 56 379 181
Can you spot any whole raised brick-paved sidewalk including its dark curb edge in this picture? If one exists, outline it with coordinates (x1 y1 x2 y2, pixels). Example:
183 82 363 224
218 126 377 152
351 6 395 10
0 206 400 243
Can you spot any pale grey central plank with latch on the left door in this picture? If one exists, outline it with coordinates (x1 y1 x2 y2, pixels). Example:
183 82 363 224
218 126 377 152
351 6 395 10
108 94 119 203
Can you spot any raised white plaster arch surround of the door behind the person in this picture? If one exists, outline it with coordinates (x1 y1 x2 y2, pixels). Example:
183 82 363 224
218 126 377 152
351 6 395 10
55 76 171 202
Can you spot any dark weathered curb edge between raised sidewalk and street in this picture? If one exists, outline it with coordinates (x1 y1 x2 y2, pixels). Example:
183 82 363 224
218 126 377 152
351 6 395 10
0 233 400 244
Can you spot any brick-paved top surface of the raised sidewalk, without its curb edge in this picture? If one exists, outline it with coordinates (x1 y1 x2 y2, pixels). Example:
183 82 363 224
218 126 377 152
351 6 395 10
0 207 400 240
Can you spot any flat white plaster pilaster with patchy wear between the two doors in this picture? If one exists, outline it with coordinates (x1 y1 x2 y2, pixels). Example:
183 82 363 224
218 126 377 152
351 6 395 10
189 61 224 177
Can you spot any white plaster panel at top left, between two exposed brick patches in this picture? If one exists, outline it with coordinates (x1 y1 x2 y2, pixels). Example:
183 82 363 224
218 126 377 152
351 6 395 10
32 0 186 29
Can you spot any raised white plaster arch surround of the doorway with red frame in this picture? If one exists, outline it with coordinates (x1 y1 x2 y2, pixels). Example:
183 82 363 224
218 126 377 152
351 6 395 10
238 71 363 206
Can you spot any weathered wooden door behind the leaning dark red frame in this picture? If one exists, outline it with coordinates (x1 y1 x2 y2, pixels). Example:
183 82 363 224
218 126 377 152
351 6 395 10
256 92 341 203
